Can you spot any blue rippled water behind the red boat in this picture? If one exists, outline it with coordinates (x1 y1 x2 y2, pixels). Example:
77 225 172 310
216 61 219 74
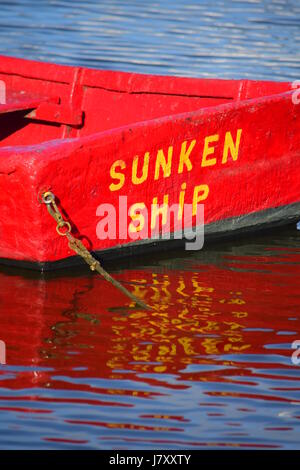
0 0 300 80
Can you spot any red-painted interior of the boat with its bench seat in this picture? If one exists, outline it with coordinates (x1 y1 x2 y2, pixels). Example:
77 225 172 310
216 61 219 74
0 56 291 147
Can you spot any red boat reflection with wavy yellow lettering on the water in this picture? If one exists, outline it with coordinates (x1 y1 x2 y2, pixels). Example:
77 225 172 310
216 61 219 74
0 250 300 392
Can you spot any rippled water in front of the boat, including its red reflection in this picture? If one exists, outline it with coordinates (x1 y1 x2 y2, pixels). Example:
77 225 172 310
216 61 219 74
0 230 300 449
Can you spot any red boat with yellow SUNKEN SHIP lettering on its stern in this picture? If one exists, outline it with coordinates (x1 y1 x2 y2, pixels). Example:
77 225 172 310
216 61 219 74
0 57 300 269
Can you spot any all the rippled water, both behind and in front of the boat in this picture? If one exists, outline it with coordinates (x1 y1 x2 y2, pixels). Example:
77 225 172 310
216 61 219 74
0 0 300 449
